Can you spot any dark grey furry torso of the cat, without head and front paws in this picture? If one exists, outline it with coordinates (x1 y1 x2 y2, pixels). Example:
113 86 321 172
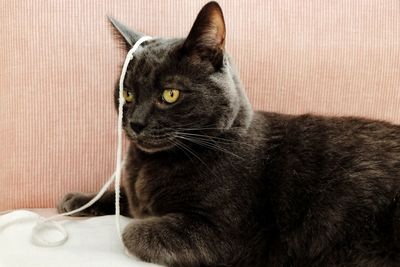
126 113 400 266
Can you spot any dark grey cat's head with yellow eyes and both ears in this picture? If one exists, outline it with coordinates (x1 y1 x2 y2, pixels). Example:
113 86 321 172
110 2 252 152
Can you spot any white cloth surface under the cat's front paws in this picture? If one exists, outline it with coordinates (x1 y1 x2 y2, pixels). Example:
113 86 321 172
0 210 159 267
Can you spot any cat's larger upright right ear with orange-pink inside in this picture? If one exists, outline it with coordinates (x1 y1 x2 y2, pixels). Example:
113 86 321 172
183 2 226 66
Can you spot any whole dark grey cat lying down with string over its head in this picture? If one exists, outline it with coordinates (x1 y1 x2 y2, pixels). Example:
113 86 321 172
59 3 400 267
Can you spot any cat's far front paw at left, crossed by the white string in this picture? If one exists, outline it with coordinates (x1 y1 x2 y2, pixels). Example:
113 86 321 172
57 193 100 216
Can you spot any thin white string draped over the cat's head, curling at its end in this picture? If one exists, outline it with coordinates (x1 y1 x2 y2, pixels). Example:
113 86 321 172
28 36 152 247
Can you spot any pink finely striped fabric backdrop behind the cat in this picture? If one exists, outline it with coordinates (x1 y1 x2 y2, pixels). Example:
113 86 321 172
0 0 400 210
